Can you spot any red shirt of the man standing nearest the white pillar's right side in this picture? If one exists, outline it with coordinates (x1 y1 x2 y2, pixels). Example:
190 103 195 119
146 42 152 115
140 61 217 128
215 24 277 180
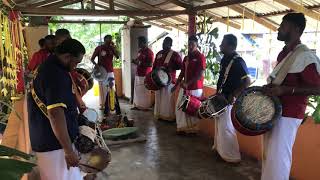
137 47 154 77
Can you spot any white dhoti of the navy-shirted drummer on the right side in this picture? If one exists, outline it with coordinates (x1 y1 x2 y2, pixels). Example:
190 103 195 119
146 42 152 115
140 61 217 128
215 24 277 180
213 105 241 162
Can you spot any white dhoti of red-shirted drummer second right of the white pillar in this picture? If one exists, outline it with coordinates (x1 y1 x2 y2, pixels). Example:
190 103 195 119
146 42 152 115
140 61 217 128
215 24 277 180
154 84 176 121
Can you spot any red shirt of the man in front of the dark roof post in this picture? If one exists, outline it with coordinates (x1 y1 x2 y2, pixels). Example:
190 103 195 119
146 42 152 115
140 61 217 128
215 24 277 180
181 51 206 90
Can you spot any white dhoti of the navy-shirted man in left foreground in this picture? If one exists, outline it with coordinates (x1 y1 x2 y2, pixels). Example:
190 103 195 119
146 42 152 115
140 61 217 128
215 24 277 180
36 149 83 180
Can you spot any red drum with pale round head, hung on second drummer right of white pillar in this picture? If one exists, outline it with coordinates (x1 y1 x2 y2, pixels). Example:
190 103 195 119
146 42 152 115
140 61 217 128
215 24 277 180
144 68 171 91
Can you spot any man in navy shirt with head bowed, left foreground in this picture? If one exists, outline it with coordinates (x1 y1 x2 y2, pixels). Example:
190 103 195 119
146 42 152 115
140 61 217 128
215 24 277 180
28 39 85 180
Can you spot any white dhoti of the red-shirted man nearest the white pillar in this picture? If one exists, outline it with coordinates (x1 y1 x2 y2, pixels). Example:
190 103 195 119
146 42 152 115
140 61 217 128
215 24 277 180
133 76 152 109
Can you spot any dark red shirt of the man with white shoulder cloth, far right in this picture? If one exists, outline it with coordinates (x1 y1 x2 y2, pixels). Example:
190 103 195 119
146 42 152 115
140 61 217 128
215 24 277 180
277 42 320 119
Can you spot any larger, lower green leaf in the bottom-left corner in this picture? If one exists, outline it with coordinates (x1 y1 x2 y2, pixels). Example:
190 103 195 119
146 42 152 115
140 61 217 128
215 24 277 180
0 158 36 180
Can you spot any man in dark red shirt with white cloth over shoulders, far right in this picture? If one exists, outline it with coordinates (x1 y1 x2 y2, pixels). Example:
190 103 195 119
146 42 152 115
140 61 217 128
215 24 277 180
261 13 320 180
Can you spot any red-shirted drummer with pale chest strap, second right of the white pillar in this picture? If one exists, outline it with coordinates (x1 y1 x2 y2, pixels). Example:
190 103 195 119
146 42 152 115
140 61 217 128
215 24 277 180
153 37 182 121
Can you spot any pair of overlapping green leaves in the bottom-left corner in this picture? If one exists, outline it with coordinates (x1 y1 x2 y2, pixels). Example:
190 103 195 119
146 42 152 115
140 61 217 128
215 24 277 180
0 145 36 180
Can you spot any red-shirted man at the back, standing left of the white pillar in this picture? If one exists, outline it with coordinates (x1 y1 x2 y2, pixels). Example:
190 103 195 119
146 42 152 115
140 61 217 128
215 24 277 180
91 35 119 109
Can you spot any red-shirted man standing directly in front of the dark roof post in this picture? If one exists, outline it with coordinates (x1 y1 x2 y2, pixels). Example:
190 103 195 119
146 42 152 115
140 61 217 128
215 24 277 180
171 36 206 133
